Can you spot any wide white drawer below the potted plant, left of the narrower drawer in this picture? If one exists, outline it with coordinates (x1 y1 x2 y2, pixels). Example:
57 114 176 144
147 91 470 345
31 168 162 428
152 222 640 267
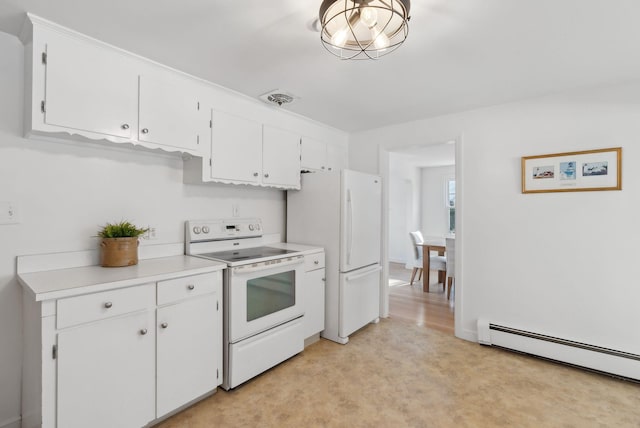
56 284 155 328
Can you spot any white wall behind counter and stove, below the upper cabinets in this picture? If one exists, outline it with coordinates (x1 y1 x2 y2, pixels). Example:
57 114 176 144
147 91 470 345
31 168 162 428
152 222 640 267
0 33 347 427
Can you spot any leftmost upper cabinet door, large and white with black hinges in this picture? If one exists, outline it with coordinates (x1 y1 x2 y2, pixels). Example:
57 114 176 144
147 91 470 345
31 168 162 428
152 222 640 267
44 36 138 139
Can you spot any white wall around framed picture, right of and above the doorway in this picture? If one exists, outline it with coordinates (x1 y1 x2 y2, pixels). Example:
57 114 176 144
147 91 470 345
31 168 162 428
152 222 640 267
350 81 640 353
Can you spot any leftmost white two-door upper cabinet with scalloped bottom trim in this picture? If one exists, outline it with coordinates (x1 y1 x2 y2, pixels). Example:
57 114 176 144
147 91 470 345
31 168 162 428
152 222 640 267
23 15 209 155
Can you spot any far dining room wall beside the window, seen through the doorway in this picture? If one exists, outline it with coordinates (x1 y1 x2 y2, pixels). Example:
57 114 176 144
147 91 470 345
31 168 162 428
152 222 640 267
420 165 456 237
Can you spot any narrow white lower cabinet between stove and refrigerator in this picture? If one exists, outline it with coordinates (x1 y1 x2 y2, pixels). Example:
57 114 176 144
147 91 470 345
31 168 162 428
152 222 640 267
303 252 325 338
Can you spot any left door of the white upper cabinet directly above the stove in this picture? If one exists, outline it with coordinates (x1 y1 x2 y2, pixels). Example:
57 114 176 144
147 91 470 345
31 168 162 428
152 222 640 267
211 110 262 184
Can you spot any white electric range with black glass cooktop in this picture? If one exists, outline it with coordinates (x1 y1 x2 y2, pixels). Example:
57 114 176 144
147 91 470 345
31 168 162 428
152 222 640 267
185 218 304 390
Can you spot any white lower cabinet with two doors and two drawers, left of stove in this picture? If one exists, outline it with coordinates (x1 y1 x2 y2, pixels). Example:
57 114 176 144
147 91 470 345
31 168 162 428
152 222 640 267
22 270 222 428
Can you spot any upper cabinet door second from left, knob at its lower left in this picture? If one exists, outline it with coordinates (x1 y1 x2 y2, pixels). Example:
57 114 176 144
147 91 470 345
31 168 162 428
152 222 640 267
138 74 202 151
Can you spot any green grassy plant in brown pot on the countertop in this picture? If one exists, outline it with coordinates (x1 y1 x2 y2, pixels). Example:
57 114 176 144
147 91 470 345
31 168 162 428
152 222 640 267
98 220 149 267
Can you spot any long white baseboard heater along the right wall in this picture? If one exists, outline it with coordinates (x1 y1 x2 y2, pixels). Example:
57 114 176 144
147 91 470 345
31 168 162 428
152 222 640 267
478 319 640 382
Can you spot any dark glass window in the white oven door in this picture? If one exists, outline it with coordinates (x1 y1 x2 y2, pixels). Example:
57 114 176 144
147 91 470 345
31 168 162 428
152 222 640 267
247 270 296 321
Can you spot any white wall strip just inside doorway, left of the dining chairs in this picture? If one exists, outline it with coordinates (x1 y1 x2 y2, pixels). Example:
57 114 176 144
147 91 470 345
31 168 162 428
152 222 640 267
389 153 421 263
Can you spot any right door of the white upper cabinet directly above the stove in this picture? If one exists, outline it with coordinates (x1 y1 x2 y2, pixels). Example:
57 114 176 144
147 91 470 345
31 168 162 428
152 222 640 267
262 125 300 189
